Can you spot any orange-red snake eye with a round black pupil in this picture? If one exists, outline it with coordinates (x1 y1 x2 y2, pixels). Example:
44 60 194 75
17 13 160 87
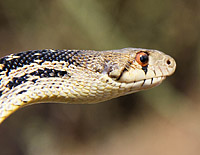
135 52 149 67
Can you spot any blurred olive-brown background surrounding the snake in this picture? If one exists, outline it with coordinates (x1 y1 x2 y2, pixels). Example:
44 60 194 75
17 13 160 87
0 0 200 155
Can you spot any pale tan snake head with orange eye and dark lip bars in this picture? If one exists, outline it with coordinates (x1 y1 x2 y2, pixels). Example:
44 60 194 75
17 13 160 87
108 48 176 89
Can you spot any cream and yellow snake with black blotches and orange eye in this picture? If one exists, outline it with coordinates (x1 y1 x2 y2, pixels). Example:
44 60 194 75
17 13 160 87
0 48 176 123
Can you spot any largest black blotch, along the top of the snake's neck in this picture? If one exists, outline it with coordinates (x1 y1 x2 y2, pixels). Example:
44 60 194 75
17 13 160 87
0 50 80 76
